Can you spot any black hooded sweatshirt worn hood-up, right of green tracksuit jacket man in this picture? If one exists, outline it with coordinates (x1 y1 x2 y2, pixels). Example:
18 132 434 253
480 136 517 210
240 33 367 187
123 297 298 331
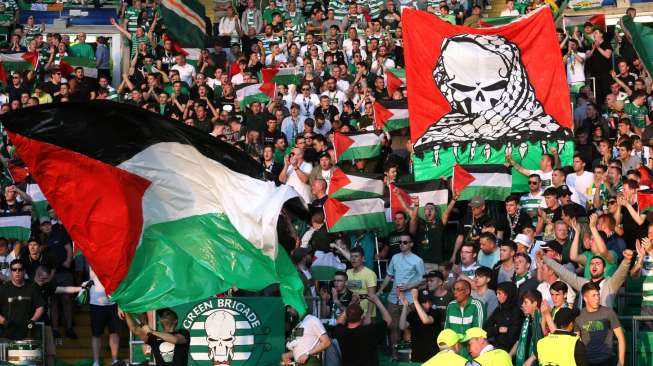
483 282 524 352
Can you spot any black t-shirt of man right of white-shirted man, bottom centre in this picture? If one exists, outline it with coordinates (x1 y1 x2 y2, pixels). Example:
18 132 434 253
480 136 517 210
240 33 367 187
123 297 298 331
333 322 387 366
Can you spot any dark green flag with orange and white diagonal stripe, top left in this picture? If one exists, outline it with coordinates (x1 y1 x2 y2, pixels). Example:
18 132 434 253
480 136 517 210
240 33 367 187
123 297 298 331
159 0 206 48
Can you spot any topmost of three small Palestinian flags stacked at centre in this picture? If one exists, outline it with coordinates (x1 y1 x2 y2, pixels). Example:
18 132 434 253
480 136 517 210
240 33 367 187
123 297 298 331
333 132 381 161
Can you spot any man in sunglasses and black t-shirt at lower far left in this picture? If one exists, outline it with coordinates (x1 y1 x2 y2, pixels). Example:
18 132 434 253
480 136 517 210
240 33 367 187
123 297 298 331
0 259 45 339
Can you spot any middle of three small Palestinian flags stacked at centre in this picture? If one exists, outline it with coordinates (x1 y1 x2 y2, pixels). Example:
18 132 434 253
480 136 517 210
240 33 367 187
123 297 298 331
328 168 385 201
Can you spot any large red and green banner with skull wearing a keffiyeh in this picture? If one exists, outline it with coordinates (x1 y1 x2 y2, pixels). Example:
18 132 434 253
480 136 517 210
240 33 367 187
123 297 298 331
402 8 574 191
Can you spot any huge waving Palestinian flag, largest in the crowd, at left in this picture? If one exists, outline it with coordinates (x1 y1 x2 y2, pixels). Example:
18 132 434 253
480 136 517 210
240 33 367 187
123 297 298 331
0 101 305 312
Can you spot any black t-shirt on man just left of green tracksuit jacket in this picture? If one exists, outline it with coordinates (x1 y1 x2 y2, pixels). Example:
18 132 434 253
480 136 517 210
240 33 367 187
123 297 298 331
406 304 442 362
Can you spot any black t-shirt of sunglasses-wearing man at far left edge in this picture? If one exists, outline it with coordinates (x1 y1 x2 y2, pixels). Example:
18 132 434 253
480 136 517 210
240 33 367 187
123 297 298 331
0 282 45 339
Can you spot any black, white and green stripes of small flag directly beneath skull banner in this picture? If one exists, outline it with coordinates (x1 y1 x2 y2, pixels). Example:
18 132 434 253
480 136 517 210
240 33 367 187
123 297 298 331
459 164 512 201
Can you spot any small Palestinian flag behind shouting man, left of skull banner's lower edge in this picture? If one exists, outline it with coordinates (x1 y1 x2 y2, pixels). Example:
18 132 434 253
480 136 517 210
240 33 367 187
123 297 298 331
390 179 449 217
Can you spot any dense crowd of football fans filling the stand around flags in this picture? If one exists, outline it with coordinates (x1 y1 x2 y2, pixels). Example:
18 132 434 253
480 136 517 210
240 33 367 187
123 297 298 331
0 0 653 366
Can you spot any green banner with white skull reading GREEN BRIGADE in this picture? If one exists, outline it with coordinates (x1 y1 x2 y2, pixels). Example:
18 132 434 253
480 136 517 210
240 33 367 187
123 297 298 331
172 297 285 366
